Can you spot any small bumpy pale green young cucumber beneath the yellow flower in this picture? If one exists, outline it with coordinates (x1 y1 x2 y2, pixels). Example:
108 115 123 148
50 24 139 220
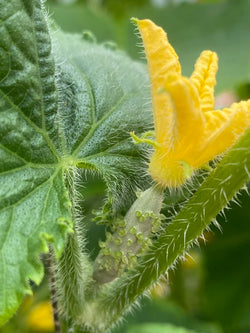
93 186 163 284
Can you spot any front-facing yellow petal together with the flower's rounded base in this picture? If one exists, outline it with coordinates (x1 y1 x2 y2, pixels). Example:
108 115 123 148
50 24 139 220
149 75 205 188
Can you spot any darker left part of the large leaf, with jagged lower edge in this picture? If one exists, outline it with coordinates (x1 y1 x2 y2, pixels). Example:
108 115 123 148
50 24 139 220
0 0 71 324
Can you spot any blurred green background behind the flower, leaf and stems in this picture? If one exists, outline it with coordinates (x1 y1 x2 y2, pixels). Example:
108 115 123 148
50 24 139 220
0 0 250 333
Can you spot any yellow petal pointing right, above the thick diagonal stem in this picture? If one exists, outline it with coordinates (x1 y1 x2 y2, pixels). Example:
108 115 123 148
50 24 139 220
195 100 250 167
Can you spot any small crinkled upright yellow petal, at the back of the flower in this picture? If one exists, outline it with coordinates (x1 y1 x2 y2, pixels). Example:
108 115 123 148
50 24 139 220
191 51 218 112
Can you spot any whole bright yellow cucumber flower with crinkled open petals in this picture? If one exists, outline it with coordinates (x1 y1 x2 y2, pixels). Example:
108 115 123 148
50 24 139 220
132 19 250 188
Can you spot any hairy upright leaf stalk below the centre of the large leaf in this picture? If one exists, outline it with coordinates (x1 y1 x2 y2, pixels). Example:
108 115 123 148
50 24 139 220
56 172 92 321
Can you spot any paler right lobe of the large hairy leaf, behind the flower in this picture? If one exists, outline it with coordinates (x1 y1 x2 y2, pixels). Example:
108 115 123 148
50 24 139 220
52 32 152 205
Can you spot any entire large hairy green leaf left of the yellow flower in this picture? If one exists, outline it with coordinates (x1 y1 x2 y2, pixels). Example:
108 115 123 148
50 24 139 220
0 0 151 323
